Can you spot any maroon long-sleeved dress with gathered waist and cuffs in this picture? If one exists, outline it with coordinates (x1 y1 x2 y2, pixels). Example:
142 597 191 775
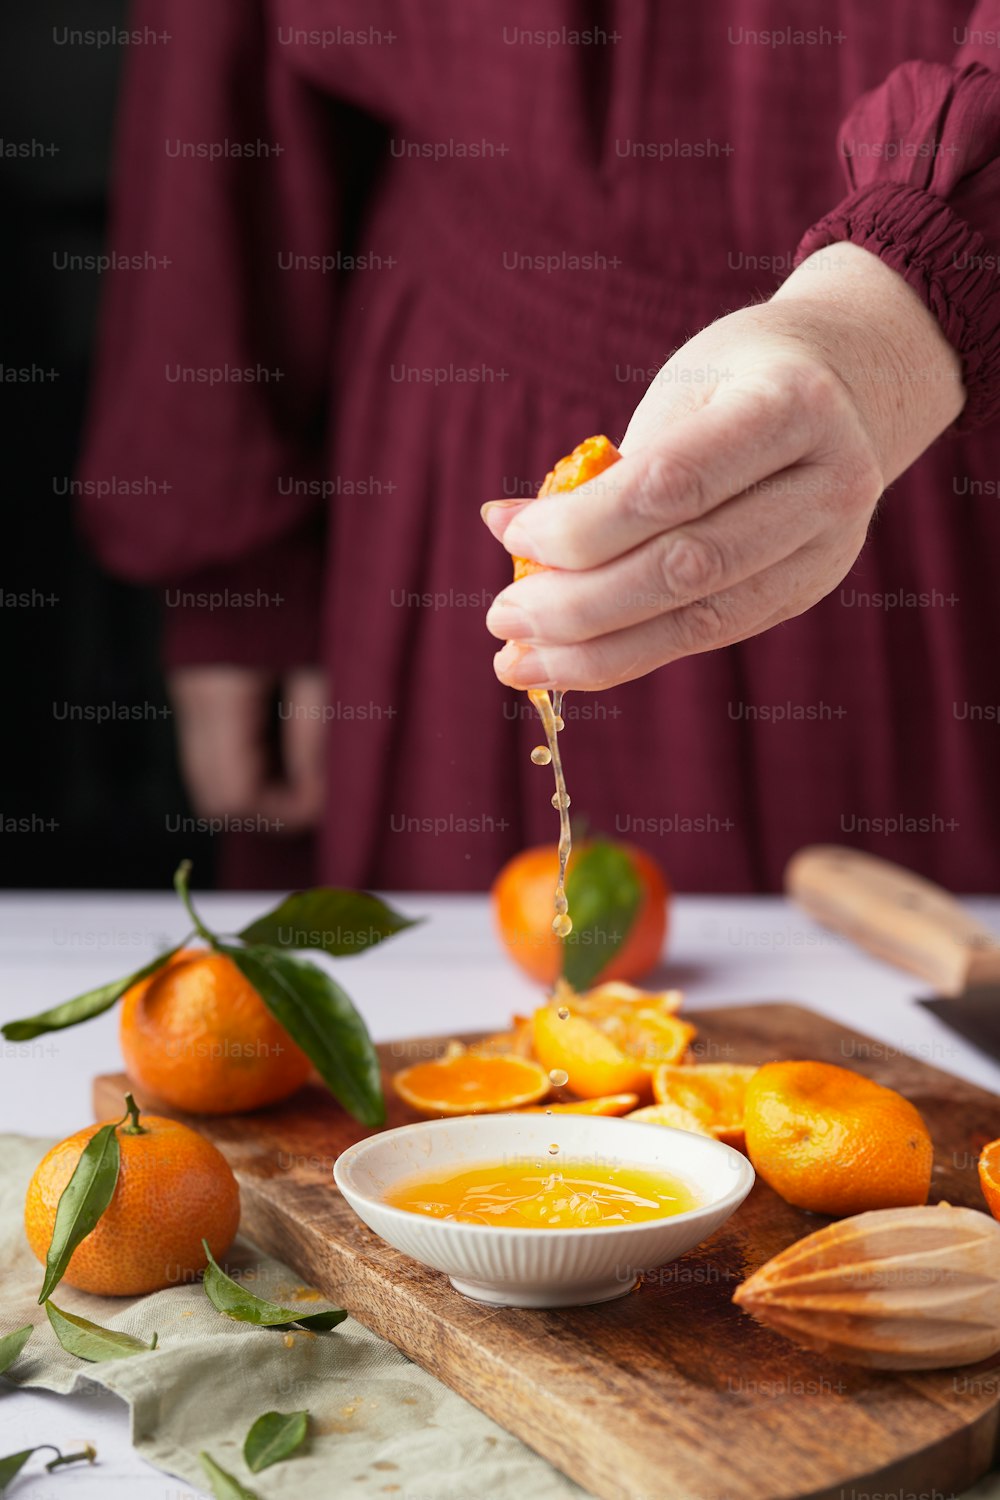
85 0 1000 891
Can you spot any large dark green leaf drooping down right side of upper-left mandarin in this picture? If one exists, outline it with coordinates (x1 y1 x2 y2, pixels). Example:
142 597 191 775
220 947 385 1125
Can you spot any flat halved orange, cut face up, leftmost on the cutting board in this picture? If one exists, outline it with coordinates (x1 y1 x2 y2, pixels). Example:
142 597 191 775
393 1052 552 1116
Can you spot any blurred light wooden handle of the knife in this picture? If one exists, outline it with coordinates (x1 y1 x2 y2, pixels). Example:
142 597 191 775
784 845 1000 995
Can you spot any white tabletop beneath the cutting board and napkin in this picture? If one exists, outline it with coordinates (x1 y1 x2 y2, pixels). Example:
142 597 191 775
0 893 1000 1500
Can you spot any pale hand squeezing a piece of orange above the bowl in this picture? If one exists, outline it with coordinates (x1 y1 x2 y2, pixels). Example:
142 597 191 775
484 245 964 690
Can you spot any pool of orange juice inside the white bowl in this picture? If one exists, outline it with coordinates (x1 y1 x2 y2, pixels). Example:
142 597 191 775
385 1158 699 1229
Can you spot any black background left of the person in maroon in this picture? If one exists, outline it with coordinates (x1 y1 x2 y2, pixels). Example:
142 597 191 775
0 0 211 888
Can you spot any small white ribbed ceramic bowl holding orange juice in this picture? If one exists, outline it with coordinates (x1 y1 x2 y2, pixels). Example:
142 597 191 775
333 1113 754 1308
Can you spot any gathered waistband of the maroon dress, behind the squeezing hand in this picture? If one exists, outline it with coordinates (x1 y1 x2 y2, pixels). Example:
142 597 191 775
359 164 790 389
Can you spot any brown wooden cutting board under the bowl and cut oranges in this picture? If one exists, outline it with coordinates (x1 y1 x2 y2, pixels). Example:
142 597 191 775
94 1005 1000 1500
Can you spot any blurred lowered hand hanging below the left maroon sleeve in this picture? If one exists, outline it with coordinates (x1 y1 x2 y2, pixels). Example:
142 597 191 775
168 666 328 833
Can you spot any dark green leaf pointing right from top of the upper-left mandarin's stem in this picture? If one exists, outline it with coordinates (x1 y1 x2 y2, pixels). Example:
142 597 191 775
238 885 418 959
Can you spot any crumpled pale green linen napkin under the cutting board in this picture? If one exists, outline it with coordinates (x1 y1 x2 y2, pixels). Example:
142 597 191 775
0 1136 585 1500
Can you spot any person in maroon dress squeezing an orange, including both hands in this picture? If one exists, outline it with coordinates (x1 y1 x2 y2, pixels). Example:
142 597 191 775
84 0 1000 891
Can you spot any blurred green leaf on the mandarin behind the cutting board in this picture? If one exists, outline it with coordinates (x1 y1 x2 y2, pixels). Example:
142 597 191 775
562 839 643 990
